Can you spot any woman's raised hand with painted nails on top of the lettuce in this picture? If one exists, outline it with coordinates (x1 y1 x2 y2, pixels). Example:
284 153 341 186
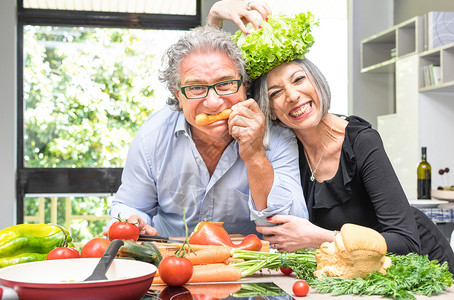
207 0 271 34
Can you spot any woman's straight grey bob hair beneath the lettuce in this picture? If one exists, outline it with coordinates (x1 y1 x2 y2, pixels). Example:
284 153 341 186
253 58 331 146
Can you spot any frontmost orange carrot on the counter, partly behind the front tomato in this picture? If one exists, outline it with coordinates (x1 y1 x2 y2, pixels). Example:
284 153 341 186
153 263 241 284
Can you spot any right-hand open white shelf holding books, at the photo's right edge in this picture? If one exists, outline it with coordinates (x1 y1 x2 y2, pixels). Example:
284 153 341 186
419 43 454 92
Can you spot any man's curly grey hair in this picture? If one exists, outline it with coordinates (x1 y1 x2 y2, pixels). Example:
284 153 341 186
159 25 249 110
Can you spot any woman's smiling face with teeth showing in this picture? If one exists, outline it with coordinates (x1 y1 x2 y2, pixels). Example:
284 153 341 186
267 62 320 129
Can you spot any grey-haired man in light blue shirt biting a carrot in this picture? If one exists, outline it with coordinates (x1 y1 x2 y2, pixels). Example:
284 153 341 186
105 26 307 236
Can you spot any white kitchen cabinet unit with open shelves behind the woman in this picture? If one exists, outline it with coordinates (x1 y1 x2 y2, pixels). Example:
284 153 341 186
361 17 454 199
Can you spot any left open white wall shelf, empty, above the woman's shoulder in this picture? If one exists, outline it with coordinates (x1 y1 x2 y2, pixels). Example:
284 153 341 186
361 16 424 73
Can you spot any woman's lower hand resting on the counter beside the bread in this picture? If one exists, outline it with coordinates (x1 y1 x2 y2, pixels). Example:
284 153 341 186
256 215 334 252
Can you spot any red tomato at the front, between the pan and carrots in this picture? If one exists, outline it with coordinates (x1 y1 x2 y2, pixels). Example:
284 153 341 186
158 256 193 286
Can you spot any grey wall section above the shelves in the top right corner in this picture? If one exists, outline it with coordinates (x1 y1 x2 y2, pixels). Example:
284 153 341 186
394 0 454 24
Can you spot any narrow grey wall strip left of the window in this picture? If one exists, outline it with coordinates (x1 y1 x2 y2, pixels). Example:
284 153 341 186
0 0 16 229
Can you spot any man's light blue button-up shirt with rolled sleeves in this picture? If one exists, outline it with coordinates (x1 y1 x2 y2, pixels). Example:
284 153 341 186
110 107 308 236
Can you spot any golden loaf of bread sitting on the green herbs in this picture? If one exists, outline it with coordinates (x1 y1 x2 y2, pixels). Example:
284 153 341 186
314 224 391 279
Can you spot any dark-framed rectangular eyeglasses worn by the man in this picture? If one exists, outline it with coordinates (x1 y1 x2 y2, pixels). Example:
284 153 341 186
178 77 243 99
